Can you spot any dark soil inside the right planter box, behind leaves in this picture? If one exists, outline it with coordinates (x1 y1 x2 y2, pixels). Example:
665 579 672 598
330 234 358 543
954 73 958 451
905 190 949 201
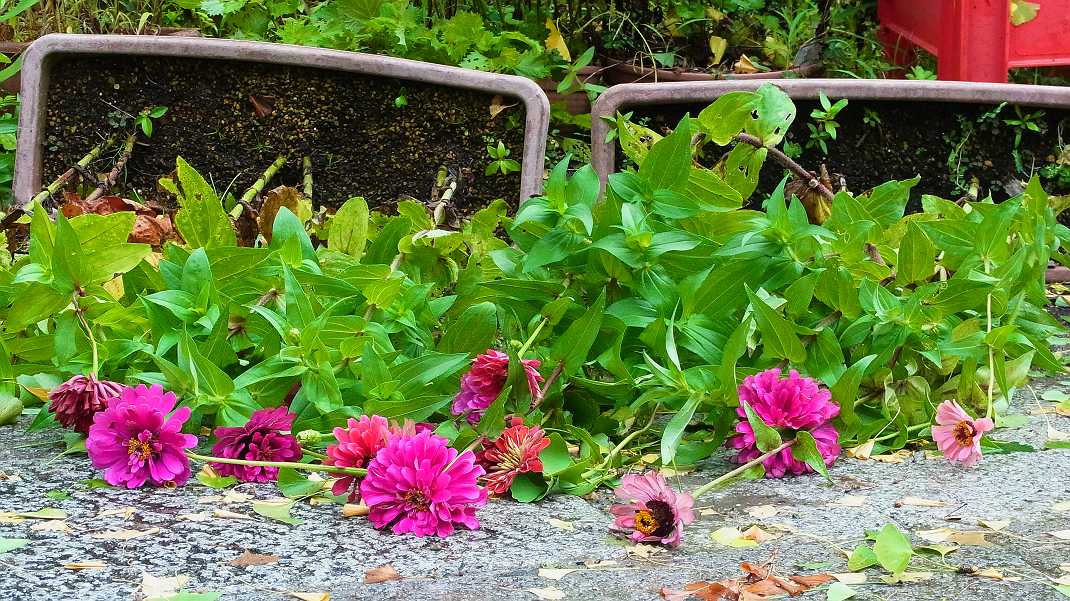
617 98 1070 211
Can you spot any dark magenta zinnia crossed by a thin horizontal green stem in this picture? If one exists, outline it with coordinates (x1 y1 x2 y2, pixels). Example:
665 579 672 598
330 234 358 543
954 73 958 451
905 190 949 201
212 406 301 482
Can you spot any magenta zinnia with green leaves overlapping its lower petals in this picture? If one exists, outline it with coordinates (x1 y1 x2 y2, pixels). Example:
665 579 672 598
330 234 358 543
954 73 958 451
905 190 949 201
728 369 840 478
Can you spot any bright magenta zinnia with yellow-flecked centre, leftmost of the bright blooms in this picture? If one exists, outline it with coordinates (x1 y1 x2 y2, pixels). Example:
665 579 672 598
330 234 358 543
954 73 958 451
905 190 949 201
86 384 197 489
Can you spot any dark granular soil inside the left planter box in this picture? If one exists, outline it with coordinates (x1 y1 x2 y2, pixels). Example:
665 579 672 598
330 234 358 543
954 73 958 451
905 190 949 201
44 57 524 215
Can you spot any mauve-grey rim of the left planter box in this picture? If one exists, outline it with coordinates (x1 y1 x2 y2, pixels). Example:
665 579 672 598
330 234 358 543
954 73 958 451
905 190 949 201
14 34 550 209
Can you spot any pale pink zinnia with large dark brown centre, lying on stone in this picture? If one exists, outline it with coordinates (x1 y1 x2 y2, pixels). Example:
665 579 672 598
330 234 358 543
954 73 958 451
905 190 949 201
609 469 694 546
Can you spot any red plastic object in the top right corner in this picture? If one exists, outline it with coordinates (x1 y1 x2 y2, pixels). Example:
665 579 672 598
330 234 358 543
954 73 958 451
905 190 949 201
877 0 1070 81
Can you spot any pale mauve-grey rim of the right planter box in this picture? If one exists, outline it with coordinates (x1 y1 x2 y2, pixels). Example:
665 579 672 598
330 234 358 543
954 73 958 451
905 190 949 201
591 79 1070 177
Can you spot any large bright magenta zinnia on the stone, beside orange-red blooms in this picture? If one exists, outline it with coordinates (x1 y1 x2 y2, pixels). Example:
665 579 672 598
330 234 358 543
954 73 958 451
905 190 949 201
361 432 487 537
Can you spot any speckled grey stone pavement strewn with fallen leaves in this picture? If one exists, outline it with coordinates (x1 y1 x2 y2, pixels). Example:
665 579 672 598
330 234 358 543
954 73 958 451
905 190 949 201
0 381 1070 601
